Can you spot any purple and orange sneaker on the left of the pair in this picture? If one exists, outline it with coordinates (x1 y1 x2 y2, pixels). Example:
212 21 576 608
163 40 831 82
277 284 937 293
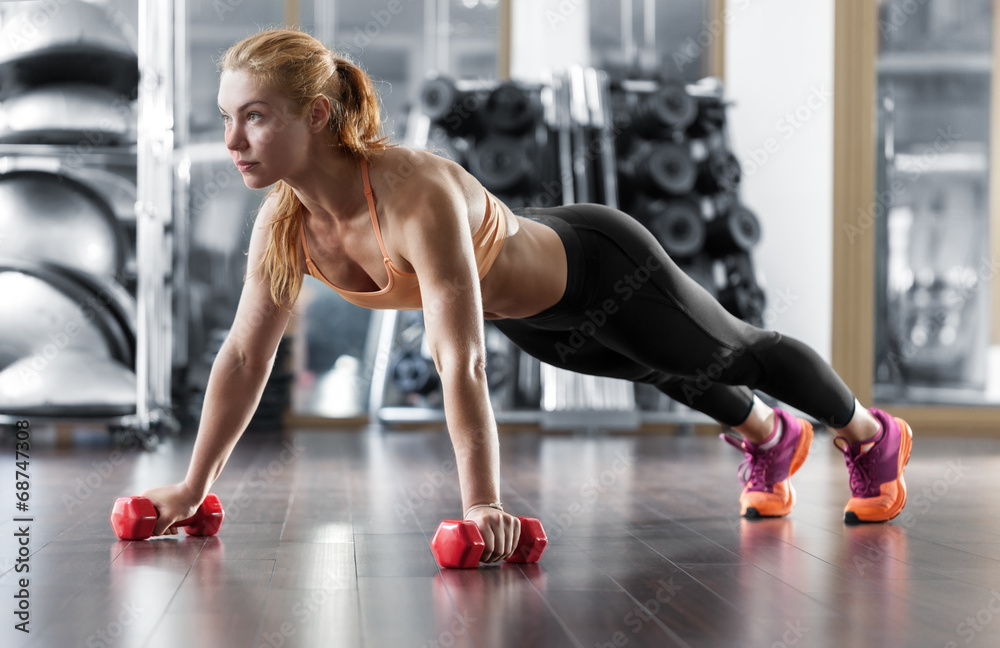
720 408 813 518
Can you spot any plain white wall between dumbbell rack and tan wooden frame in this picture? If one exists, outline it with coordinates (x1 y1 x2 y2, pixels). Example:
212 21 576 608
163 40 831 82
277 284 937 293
725 0 834 361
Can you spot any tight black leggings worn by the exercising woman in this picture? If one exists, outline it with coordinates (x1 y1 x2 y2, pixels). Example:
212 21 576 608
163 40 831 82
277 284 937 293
494 204 854 427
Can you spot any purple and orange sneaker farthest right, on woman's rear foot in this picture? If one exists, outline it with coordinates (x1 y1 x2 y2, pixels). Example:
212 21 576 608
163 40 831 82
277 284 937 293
833 408 913 524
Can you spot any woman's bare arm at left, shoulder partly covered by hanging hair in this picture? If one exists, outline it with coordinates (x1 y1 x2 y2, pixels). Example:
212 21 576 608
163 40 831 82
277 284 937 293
143 200 290 535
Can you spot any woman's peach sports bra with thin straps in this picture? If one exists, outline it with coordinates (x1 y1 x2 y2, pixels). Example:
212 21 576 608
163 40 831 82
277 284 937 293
299 160 507 310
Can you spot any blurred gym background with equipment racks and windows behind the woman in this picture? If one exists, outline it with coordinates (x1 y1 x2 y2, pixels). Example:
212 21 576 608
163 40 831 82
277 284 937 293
0 0 1000 446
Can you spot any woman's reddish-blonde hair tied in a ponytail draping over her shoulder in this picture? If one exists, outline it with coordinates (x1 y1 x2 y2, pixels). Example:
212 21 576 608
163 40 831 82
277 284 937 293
219 29 393 308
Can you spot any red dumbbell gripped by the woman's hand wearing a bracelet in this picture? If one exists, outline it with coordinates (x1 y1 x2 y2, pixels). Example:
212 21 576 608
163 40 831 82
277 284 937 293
431 517 549 569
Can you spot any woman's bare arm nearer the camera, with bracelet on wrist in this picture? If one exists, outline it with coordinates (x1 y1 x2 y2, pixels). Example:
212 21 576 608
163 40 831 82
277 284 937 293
402 178 520 562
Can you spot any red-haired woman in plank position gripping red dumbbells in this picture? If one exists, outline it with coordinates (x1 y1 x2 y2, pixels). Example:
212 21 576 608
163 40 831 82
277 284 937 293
144 30 911 562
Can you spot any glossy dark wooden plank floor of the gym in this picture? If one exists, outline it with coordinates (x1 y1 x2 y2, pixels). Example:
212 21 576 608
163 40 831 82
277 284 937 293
0 422 1000 648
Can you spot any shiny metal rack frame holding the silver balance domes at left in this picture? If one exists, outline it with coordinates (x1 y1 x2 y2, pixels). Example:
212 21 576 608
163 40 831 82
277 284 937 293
0 0 184 449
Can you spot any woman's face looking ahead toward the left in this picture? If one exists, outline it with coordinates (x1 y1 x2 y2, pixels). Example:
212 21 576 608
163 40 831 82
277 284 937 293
219 70 312 189
